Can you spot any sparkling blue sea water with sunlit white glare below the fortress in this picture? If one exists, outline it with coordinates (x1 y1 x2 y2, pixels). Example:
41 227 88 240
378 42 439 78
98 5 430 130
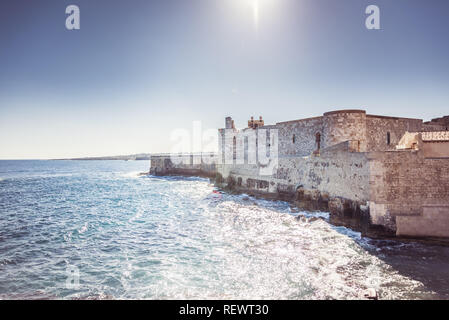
0 161 449 299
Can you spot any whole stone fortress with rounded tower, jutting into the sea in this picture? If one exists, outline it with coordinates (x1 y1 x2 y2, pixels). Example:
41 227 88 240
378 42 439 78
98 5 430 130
150 110 449 238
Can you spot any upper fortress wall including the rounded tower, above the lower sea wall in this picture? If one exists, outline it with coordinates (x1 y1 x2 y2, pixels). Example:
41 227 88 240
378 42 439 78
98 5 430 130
221 110 430 160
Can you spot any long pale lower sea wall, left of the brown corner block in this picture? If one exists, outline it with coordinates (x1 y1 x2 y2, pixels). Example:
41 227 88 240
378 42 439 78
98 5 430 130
218 142 369 202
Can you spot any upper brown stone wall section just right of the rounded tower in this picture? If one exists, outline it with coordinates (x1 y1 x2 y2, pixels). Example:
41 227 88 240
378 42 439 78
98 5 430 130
366 115 422 151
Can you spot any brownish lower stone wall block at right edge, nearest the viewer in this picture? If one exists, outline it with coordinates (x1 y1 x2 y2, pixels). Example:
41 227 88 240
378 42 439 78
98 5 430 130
369 151 449 237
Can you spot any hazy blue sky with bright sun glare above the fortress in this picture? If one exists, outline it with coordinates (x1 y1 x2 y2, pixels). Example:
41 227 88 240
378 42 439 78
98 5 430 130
0 0 449 159
